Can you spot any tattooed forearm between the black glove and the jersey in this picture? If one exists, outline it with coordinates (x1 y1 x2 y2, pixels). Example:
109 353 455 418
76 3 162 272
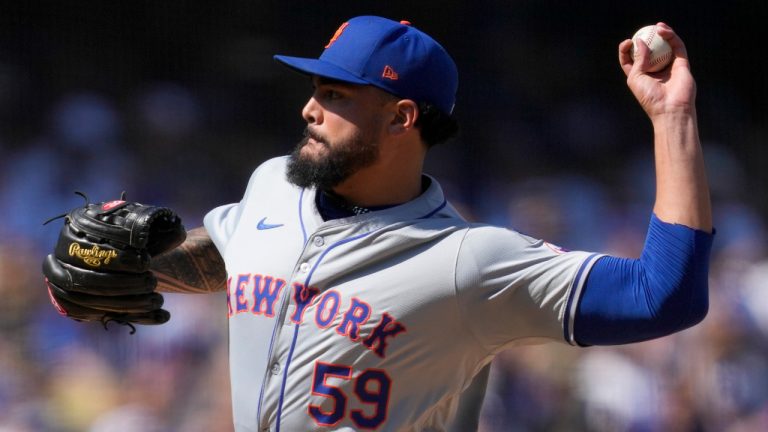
151 227 227 293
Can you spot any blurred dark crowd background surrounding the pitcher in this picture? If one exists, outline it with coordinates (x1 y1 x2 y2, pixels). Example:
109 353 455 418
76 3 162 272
0 0 768 432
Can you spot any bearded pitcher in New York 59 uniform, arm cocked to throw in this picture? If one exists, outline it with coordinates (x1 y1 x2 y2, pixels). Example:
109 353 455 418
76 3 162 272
44 16 713 432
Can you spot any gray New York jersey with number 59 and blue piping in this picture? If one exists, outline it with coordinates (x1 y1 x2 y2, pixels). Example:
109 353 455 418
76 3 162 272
205 158 597 432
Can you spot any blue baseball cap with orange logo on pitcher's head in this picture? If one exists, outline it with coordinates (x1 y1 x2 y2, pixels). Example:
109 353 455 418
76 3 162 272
274 16 459 114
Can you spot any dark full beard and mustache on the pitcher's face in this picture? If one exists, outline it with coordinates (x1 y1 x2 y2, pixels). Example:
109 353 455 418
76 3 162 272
287 128 379 191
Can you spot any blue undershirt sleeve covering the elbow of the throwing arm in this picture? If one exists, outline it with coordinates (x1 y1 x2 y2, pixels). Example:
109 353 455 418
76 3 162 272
574 215 714 346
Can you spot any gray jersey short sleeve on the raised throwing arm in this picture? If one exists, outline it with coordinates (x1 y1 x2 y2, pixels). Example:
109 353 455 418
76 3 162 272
455 226 600 352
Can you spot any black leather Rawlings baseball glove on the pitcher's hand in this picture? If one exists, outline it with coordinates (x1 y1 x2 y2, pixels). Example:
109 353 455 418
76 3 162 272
43 194 186 331
